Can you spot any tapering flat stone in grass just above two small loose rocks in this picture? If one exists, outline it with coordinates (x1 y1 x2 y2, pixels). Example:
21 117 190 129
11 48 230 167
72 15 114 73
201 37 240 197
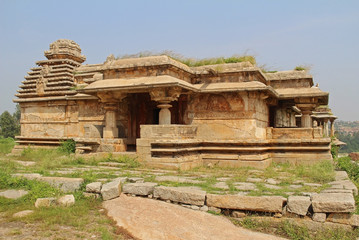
39 177 84 192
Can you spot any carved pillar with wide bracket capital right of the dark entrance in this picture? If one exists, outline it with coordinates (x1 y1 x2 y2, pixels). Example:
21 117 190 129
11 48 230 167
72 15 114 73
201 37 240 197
150 87 182 125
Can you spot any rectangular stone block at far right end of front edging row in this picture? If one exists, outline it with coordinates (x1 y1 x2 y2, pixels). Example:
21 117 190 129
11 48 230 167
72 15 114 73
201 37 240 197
312 193 355 213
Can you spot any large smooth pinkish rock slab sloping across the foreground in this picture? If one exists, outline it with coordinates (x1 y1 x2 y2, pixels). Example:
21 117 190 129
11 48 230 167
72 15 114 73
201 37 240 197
103 194 283 240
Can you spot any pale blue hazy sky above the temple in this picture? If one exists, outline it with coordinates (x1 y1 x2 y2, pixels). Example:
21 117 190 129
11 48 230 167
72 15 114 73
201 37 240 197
0 0 359 120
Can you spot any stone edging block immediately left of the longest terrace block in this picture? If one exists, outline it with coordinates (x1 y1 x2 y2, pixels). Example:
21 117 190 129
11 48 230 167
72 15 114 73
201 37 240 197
153 186 206 206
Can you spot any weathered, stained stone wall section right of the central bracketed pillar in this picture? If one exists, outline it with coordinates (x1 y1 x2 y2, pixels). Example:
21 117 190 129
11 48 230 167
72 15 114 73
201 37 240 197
184 92 268 139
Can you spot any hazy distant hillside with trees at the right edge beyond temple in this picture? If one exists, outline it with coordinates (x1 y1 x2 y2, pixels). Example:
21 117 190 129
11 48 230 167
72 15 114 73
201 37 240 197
335 121 359 153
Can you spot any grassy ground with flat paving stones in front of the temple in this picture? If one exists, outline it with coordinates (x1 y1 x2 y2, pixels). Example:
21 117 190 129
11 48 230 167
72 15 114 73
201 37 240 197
0 152 357 239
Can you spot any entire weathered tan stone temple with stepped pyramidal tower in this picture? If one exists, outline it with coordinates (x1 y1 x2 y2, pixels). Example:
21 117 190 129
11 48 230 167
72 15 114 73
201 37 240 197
13 39 335 169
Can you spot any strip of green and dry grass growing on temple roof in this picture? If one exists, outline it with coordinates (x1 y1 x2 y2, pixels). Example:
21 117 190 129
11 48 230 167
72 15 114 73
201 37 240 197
116 51 256 67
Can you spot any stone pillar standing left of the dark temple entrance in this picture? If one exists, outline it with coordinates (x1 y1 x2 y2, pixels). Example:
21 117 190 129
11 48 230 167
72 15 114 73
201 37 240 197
103 103 118 139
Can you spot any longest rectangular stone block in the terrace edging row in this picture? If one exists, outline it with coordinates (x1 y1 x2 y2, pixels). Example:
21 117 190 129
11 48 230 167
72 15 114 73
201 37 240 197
207 194 284 212
